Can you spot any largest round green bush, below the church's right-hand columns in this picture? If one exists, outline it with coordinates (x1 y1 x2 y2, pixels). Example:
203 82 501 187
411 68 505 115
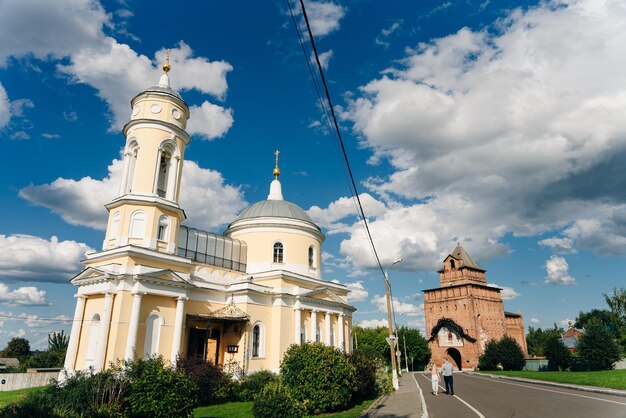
280 343 355 414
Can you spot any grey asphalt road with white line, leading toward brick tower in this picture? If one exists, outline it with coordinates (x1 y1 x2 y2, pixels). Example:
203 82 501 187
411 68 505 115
414 373 626 418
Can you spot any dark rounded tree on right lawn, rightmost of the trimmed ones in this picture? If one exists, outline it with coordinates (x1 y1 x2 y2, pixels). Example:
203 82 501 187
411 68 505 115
576 320 622 370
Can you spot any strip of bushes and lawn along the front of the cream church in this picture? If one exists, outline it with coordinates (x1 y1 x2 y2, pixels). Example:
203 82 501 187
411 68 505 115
0 343 398 418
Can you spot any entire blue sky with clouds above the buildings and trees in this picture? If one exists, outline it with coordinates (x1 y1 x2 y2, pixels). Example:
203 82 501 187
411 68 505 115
0 0 626 348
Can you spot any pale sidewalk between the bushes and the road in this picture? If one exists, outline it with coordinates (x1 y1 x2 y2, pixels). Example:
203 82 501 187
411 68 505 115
361 372 423 418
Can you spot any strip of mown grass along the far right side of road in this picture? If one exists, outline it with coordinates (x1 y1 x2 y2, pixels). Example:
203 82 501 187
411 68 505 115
485 370 626 390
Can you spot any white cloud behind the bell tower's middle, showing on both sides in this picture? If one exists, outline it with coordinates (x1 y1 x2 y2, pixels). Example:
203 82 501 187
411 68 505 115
20 160 246 230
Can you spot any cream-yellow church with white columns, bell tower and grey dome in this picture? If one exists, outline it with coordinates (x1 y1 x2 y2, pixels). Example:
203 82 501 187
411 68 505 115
64 59 355 374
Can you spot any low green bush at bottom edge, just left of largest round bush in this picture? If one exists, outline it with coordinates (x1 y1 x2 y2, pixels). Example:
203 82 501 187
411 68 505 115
252 382 305 418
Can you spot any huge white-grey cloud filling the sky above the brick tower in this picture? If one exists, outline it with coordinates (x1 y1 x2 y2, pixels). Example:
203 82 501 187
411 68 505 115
330 0 626 272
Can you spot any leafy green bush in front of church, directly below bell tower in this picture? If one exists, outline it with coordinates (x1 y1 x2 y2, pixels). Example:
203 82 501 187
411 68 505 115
126 356 198 418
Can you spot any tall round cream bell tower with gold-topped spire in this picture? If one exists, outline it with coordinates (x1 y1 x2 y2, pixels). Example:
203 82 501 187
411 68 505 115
102 50 190 254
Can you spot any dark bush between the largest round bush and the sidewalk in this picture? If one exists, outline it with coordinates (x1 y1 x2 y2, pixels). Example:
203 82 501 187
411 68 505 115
348 350 391 402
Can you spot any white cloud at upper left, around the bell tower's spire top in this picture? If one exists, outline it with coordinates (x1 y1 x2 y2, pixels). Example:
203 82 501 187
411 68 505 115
0 0 233 139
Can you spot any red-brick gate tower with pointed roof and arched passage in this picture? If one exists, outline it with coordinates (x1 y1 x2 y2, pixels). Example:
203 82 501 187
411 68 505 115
424 244 528 370
